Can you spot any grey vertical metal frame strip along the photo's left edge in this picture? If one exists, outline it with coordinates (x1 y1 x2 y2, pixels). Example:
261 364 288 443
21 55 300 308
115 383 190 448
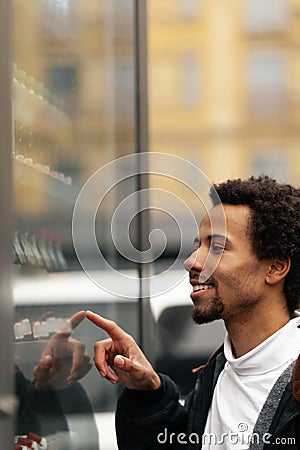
0 0 16 448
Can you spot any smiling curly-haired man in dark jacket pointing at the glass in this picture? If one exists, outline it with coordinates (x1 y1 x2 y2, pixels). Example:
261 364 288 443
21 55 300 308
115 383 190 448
87 176 300 450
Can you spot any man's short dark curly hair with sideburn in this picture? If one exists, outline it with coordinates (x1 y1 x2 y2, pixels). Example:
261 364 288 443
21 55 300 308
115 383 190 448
210 175 300 316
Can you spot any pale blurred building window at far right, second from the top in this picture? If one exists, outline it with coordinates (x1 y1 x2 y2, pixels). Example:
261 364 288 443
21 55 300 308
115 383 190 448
246 52 287 116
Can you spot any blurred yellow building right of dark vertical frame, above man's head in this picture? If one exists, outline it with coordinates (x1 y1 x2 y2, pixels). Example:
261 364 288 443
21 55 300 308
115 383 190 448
148 0 300 184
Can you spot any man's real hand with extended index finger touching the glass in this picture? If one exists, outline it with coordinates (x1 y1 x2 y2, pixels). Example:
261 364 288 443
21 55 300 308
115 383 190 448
86 311 161 391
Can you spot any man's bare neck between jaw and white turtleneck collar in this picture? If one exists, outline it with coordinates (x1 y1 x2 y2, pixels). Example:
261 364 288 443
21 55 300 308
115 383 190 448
225 302 290 358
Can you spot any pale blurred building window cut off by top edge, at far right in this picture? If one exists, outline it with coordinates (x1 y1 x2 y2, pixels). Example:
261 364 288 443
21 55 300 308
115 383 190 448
244 0 289 33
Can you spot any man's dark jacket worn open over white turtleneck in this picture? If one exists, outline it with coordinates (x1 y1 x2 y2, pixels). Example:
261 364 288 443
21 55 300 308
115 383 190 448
116 351 300 450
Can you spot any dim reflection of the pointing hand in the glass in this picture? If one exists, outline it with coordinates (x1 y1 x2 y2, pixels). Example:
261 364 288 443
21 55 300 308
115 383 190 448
33 311 92 390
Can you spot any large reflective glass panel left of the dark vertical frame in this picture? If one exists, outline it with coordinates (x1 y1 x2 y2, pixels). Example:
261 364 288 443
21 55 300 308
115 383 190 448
12 0 139 450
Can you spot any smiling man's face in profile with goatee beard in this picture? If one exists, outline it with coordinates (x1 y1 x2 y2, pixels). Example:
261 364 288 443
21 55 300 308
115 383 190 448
184 205 266 323
